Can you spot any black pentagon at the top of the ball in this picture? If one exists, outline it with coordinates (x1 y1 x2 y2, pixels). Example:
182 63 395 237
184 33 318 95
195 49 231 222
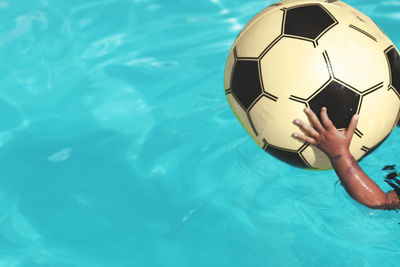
284 5 335 39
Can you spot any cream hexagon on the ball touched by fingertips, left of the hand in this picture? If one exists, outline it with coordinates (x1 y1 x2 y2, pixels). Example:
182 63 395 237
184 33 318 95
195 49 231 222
249 96 307 150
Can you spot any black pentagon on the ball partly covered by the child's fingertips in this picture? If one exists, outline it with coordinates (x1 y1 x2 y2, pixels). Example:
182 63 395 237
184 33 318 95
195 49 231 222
308 81 360 129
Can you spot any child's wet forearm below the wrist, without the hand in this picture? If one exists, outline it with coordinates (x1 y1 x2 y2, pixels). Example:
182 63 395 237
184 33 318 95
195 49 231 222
331 151 400 209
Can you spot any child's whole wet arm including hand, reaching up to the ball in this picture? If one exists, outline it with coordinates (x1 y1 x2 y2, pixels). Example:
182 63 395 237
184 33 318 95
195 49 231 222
293 108 400 209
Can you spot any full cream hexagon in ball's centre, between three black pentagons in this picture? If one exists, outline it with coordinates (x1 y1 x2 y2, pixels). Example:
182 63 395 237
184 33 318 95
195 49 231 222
260 37 329 98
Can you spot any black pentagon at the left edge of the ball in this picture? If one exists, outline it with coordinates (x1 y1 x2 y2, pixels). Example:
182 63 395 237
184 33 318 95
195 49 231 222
231 60 262 110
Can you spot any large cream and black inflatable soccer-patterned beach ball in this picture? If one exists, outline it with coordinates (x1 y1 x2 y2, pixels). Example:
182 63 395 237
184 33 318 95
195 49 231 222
224 0 400 169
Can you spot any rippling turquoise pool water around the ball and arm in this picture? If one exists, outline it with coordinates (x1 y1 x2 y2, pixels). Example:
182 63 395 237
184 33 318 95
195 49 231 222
0 0 400 267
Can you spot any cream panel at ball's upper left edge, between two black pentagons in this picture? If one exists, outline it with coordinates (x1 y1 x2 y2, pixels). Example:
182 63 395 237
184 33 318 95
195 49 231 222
236 9 283 58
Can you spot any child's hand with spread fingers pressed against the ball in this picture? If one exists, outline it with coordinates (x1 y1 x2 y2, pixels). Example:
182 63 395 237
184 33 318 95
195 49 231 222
293 107 358 159
